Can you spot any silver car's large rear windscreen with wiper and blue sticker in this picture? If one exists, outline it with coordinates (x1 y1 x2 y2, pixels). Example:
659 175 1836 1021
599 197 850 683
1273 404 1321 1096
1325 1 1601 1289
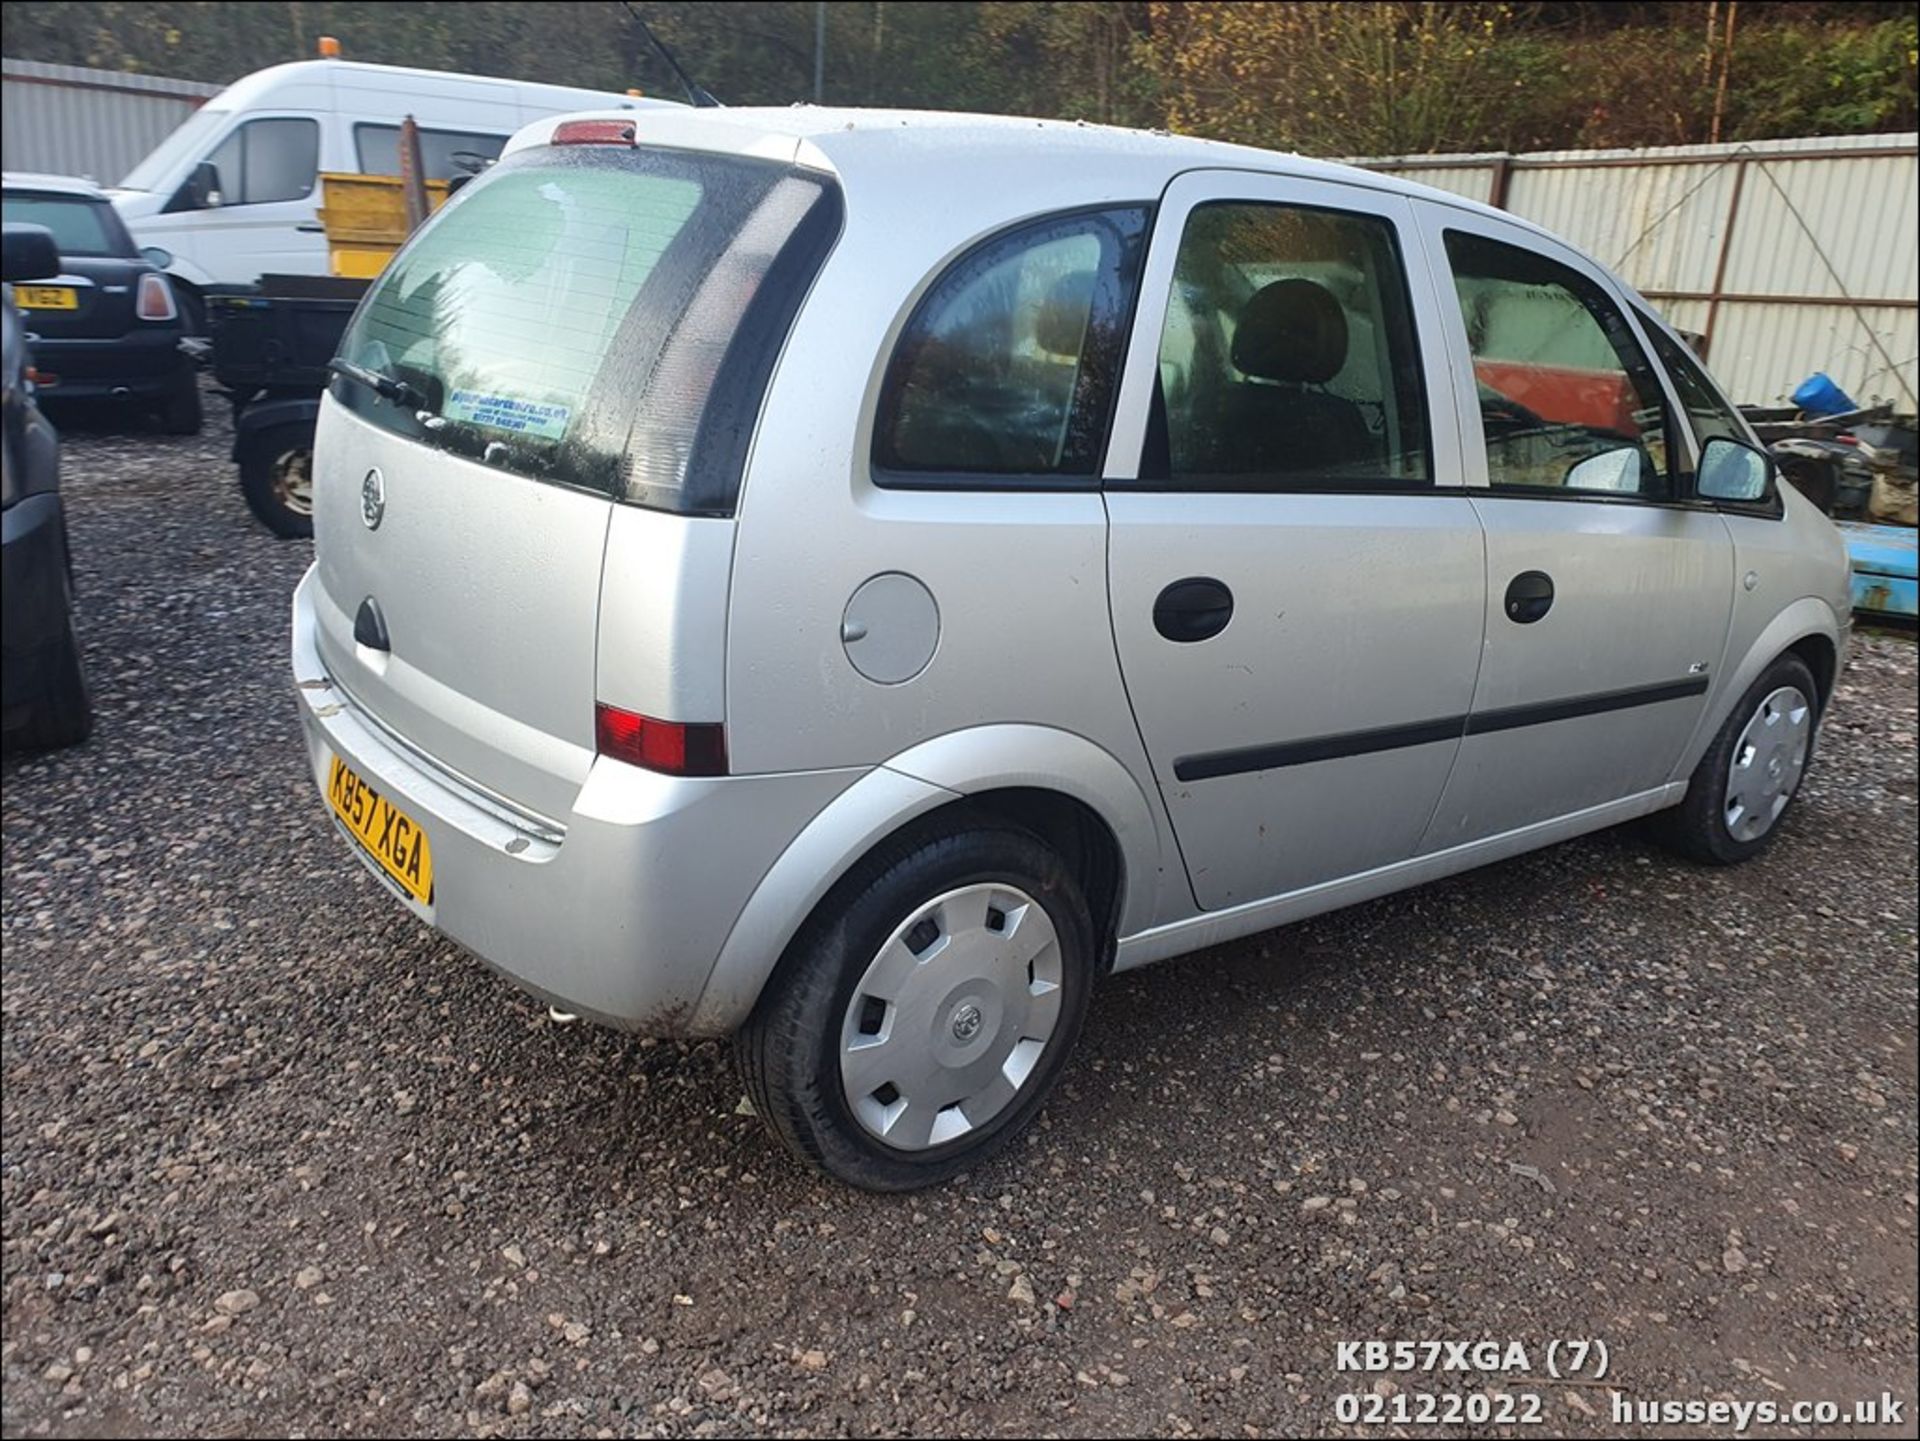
332 146 839 512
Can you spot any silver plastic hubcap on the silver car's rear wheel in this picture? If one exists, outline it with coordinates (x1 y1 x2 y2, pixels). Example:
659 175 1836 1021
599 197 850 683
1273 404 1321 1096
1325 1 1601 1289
841 885 1062 1151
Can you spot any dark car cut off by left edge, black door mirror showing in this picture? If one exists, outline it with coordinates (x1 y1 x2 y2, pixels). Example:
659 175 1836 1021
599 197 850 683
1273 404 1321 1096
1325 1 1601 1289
0 224 92 750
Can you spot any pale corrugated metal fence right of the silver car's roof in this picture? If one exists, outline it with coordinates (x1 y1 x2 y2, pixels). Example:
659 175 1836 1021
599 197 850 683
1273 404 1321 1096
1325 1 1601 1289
1357 134 1920 411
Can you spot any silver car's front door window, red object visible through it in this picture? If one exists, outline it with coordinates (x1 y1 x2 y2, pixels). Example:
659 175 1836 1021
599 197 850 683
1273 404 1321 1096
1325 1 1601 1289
1446 230 1670 499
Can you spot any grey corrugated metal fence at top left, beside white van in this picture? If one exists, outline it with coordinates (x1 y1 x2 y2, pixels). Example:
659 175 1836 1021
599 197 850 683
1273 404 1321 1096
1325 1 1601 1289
0 59 221 184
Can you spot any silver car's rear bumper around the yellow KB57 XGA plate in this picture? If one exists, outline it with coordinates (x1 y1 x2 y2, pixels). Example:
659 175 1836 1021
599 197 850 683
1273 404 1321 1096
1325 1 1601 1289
292 570 862 1034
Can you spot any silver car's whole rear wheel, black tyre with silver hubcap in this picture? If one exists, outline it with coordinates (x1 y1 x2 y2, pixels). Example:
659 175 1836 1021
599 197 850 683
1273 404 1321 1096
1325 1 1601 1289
735 827 1096 1192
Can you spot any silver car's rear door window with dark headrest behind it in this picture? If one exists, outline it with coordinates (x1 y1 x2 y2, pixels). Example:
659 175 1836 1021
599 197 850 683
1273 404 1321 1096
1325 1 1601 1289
1142 201 1432 491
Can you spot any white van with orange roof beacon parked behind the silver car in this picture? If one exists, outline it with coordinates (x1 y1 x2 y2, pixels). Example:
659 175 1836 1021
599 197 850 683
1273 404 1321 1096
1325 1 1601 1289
108 50 674 319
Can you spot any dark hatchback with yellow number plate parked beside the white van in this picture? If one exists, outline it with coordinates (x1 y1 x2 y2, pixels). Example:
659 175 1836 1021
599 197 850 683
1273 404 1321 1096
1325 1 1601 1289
0 173 200 436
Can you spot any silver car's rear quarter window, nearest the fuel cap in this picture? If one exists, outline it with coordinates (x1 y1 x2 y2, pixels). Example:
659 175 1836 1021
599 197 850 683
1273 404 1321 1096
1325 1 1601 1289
874 207 1146 485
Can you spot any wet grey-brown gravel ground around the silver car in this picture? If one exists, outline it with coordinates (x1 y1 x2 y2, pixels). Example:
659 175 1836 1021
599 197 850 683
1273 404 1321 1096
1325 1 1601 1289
0 389 1920 1435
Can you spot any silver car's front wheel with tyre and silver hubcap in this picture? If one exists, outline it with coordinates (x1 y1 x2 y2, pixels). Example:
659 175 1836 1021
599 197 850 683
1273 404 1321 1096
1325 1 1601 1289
1659 656 1820 865
